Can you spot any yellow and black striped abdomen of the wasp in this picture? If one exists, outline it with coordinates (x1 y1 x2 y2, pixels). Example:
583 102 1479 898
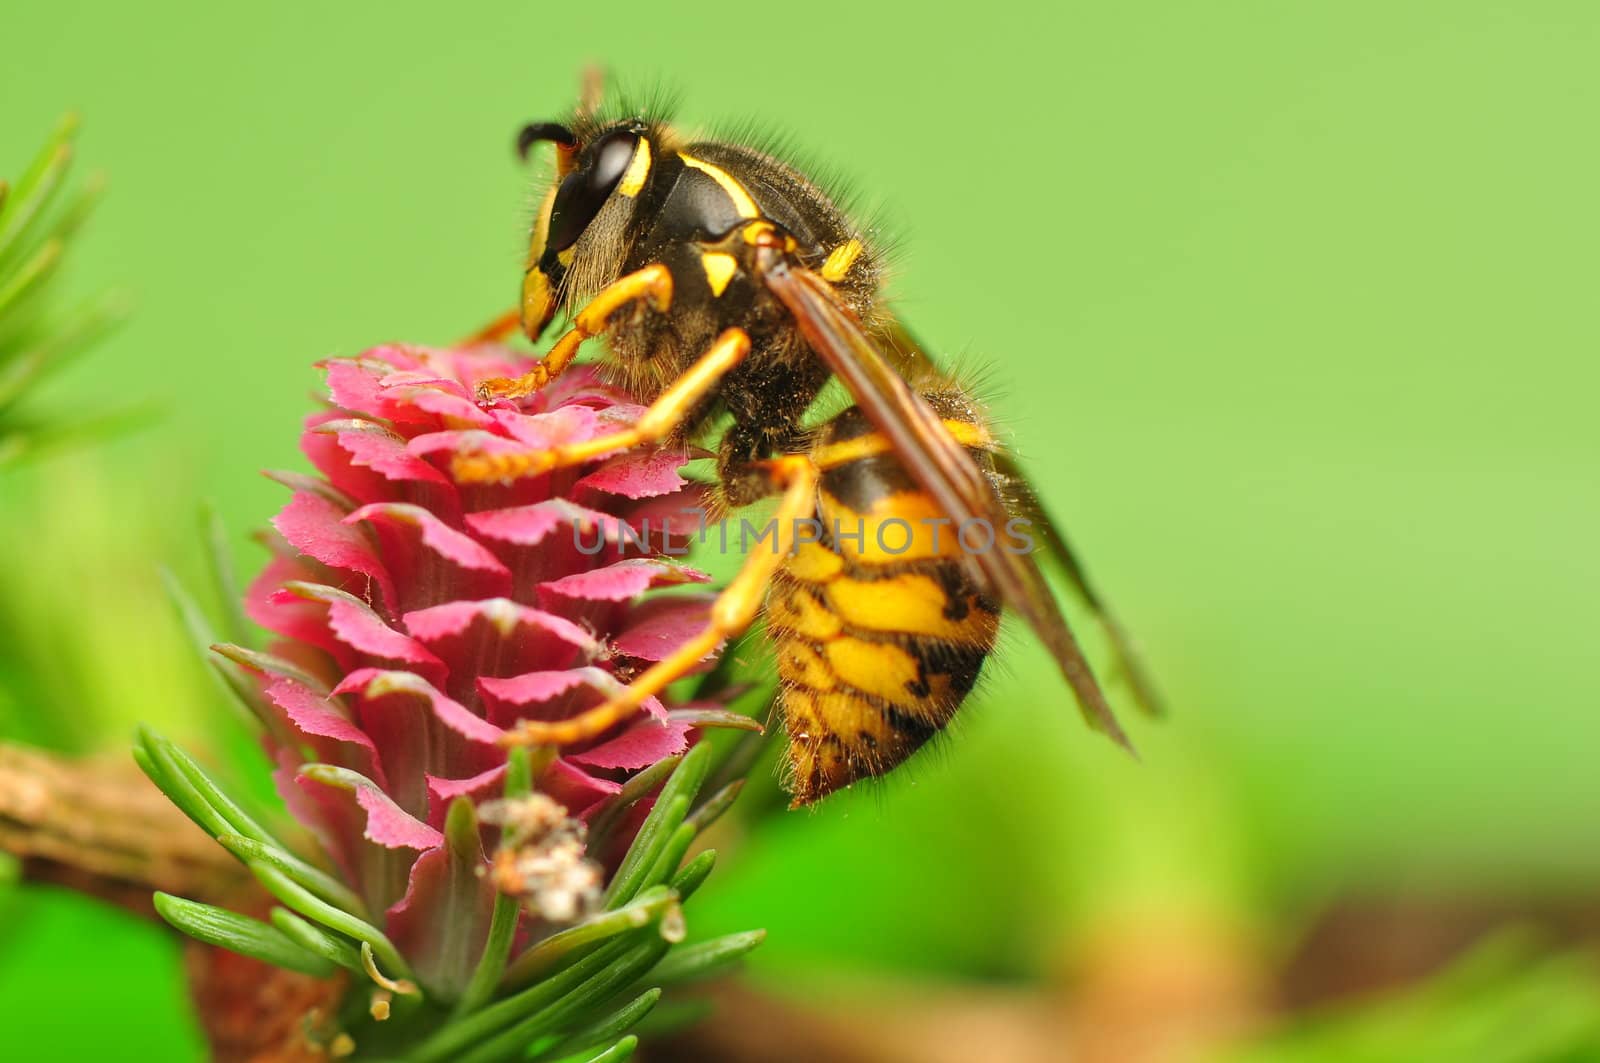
766 410 1000 805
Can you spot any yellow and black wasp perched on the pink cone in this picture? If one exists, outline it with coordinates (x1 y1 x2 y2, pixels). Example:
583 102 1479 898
453 89 1155 807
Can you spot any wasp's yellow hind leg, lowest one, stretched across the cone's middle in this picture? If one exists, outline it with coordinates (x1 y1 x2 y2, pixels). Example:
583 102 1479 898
501 455 821 746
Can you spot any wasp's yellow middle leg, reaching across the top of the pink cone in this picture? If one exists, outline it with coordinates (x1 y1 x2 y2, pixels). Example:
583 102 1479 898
450 328 750 483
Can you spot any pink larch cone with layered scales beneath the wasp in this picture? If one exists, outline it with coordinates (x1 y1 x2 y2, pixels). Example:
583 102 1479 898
230 346 726 997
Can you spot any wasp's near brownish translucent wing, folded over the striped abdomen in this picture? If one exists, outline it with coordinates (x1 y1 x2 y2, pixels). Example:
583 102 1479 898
765 261 1133 751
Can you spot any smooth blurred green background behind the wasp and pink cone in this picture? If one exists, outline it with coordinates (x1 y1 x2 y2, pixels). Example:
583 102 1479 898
0 2 1600 1060
